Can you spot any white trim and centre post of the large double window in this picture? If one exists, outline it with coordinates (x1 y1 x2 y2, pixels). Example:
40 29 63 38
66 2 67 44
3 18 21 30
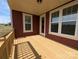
49 1 78 40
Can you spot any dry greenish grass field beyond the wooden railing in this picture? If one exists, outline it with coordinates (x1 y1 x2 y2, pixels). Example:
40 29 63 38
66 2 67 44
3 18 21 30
0 24 12 37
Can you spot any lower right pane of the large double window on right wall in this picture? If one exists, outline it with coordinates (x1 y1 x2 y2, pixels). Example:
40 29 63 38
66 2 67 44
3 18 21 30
62 21 76 35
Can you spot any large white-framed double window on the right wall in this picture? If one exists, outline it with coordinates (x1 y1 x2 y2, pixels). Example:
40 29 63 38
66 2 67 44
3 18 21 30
49 2 78 39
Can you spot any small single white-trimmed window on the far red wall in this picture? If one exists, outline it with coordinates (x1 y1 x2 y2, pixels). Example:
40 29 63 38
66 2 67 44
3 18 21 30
23 14 32 32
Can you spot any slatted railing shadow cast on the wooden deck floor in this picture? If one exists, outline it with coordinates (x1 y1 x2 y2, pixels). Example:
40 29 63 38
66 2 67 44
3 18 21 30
14 41 41 59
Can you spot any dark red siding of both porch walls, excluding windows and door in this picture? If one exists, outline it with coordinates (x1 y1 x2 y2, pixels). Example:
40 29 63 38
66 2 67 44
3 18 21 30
12 0 78 49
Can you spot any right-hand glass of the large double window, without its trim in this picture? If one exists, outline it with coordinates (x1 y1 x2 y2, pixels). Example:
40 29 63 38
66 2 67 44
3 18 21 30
61 5 78 35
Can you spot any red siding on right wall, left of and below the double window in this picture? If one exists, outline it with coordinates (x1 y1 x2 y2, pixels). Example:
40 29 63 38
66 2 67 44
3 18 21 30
46 12 78 49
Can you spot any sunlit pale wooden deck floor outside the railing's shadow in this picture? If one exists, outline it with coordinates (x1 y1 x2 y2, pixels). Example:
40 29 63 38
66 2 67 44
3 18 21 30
14 35 78 59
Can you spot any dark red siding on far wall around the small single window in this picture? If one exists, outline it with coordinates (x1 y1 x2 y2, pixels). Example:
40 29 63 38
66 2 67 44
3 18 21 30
12 10 39 38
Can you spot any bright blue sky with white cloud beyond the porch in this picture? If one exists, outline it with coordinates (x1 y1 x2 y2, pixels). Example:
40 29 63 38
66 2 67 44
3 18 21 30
0 0 11 24
